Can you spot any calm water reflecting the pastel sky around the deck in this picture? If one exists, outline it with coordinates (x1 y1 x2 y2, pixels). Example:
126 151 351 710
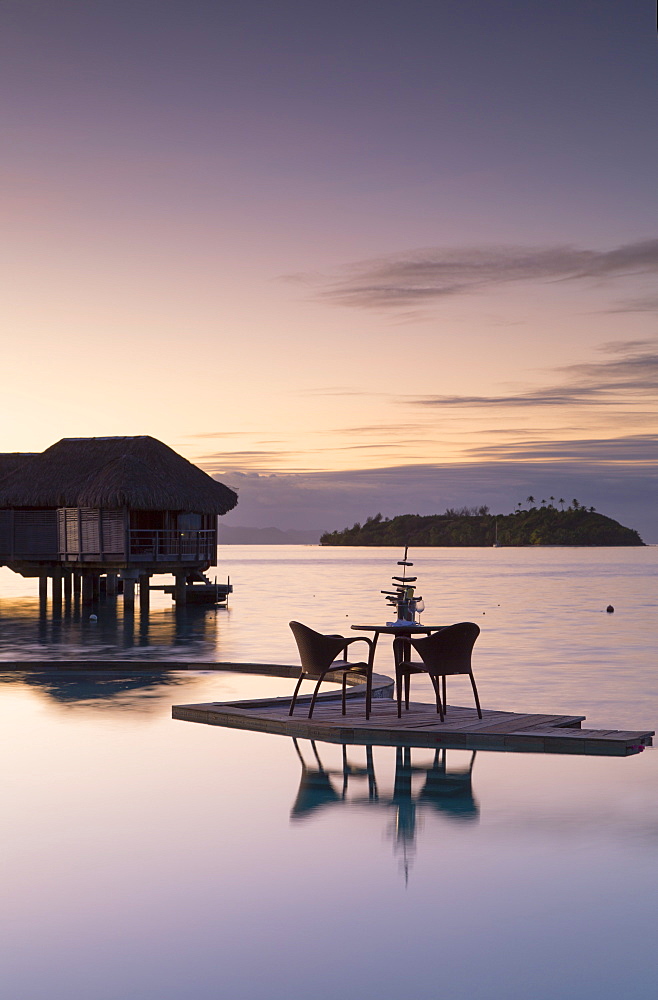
0 546 658 1000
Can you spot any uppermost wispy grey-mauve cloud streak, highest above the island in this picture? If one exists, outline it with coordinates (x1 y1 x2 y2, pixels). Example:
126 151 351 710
309 240 658 310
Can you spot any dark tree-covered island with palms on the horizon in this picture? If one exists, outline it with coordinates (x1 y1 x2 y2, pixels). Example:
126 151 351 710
320 497 644 546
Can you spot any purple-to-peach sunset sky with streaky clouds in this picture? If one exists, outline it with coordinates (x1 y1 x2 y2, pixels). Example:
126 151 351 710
0 0 658 542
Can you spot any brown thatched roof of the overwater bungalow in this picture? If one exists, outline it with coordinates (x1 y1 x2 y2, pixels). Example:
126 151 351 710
0 436 238 514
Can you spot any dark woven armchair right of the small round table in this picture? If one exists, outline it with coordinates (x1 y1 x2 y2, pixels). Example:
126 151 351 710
393 622 482 722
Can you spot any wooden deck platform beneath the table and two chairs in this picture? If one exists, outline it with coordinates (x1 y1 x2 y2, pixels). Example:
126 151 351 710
172 676 654 757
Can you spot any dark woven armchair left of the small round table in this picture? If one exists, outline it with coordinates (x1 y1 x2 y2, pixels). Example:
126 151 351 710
288 622 374 719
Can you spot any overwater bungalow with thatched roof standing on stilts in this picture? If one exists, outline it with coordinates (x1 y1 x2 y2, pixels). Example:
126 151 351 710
0 436 237 602
